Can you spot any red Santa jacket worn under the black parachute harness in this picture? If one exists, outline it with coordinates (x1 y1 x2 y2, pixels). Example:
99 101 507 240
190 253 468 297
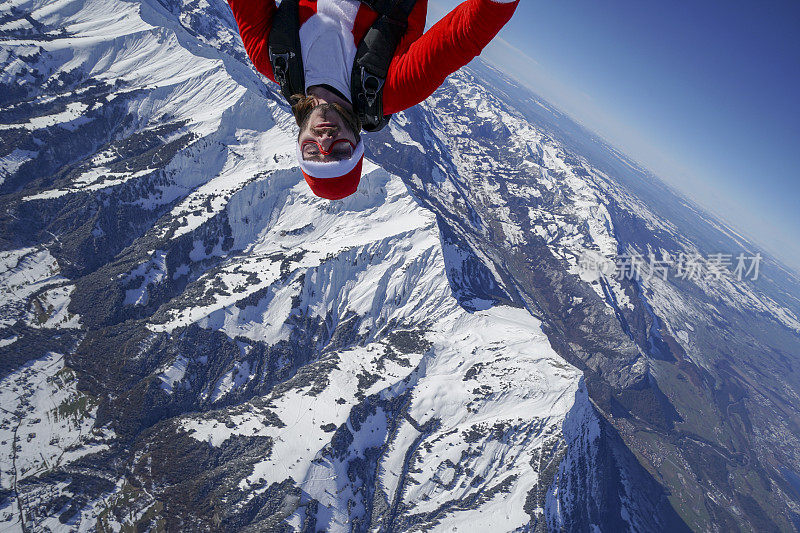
229 0 519 114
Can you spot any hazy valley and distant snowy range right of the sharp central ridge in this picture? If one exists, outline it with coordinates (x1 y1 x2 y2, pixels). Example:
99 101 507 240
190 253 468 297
373 60 800 530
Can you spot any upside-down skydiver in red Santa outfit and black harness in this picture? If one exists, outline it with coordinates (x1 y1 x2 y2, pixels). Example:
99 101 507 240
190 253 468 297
229 0 519 200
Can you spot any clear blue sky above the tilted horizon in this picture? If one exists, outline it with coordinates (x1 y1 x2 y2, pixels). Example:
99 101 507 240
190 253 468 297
428 0 800 270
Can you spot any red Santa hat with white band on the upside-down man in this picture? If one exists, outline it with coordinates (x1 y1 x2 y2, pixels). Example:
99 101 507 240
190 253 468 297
297 141 364 200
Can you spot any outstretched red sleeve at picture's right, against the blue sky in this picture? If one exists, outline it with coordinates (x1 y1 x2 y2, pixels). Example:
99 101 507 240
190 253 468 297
383 0 519 114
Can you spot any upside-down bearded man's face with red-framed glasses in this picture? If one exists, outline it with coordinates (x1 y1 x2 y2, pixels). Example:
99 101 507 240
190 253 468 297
297 104 358 163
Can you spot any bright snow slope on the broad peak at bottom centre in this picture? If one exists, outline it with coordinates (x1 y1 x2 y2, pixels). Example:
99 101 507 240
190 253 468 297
386 306 579 531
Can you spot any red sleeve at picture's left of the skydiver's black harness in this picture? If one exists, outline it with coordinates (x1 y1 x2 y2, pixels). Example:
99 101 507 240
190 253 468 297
228 0 278 81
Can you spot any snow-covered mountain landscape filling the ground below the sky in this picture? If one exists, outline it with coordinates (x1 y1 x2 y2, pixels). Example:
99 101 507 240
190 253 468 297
0 0 800 531
